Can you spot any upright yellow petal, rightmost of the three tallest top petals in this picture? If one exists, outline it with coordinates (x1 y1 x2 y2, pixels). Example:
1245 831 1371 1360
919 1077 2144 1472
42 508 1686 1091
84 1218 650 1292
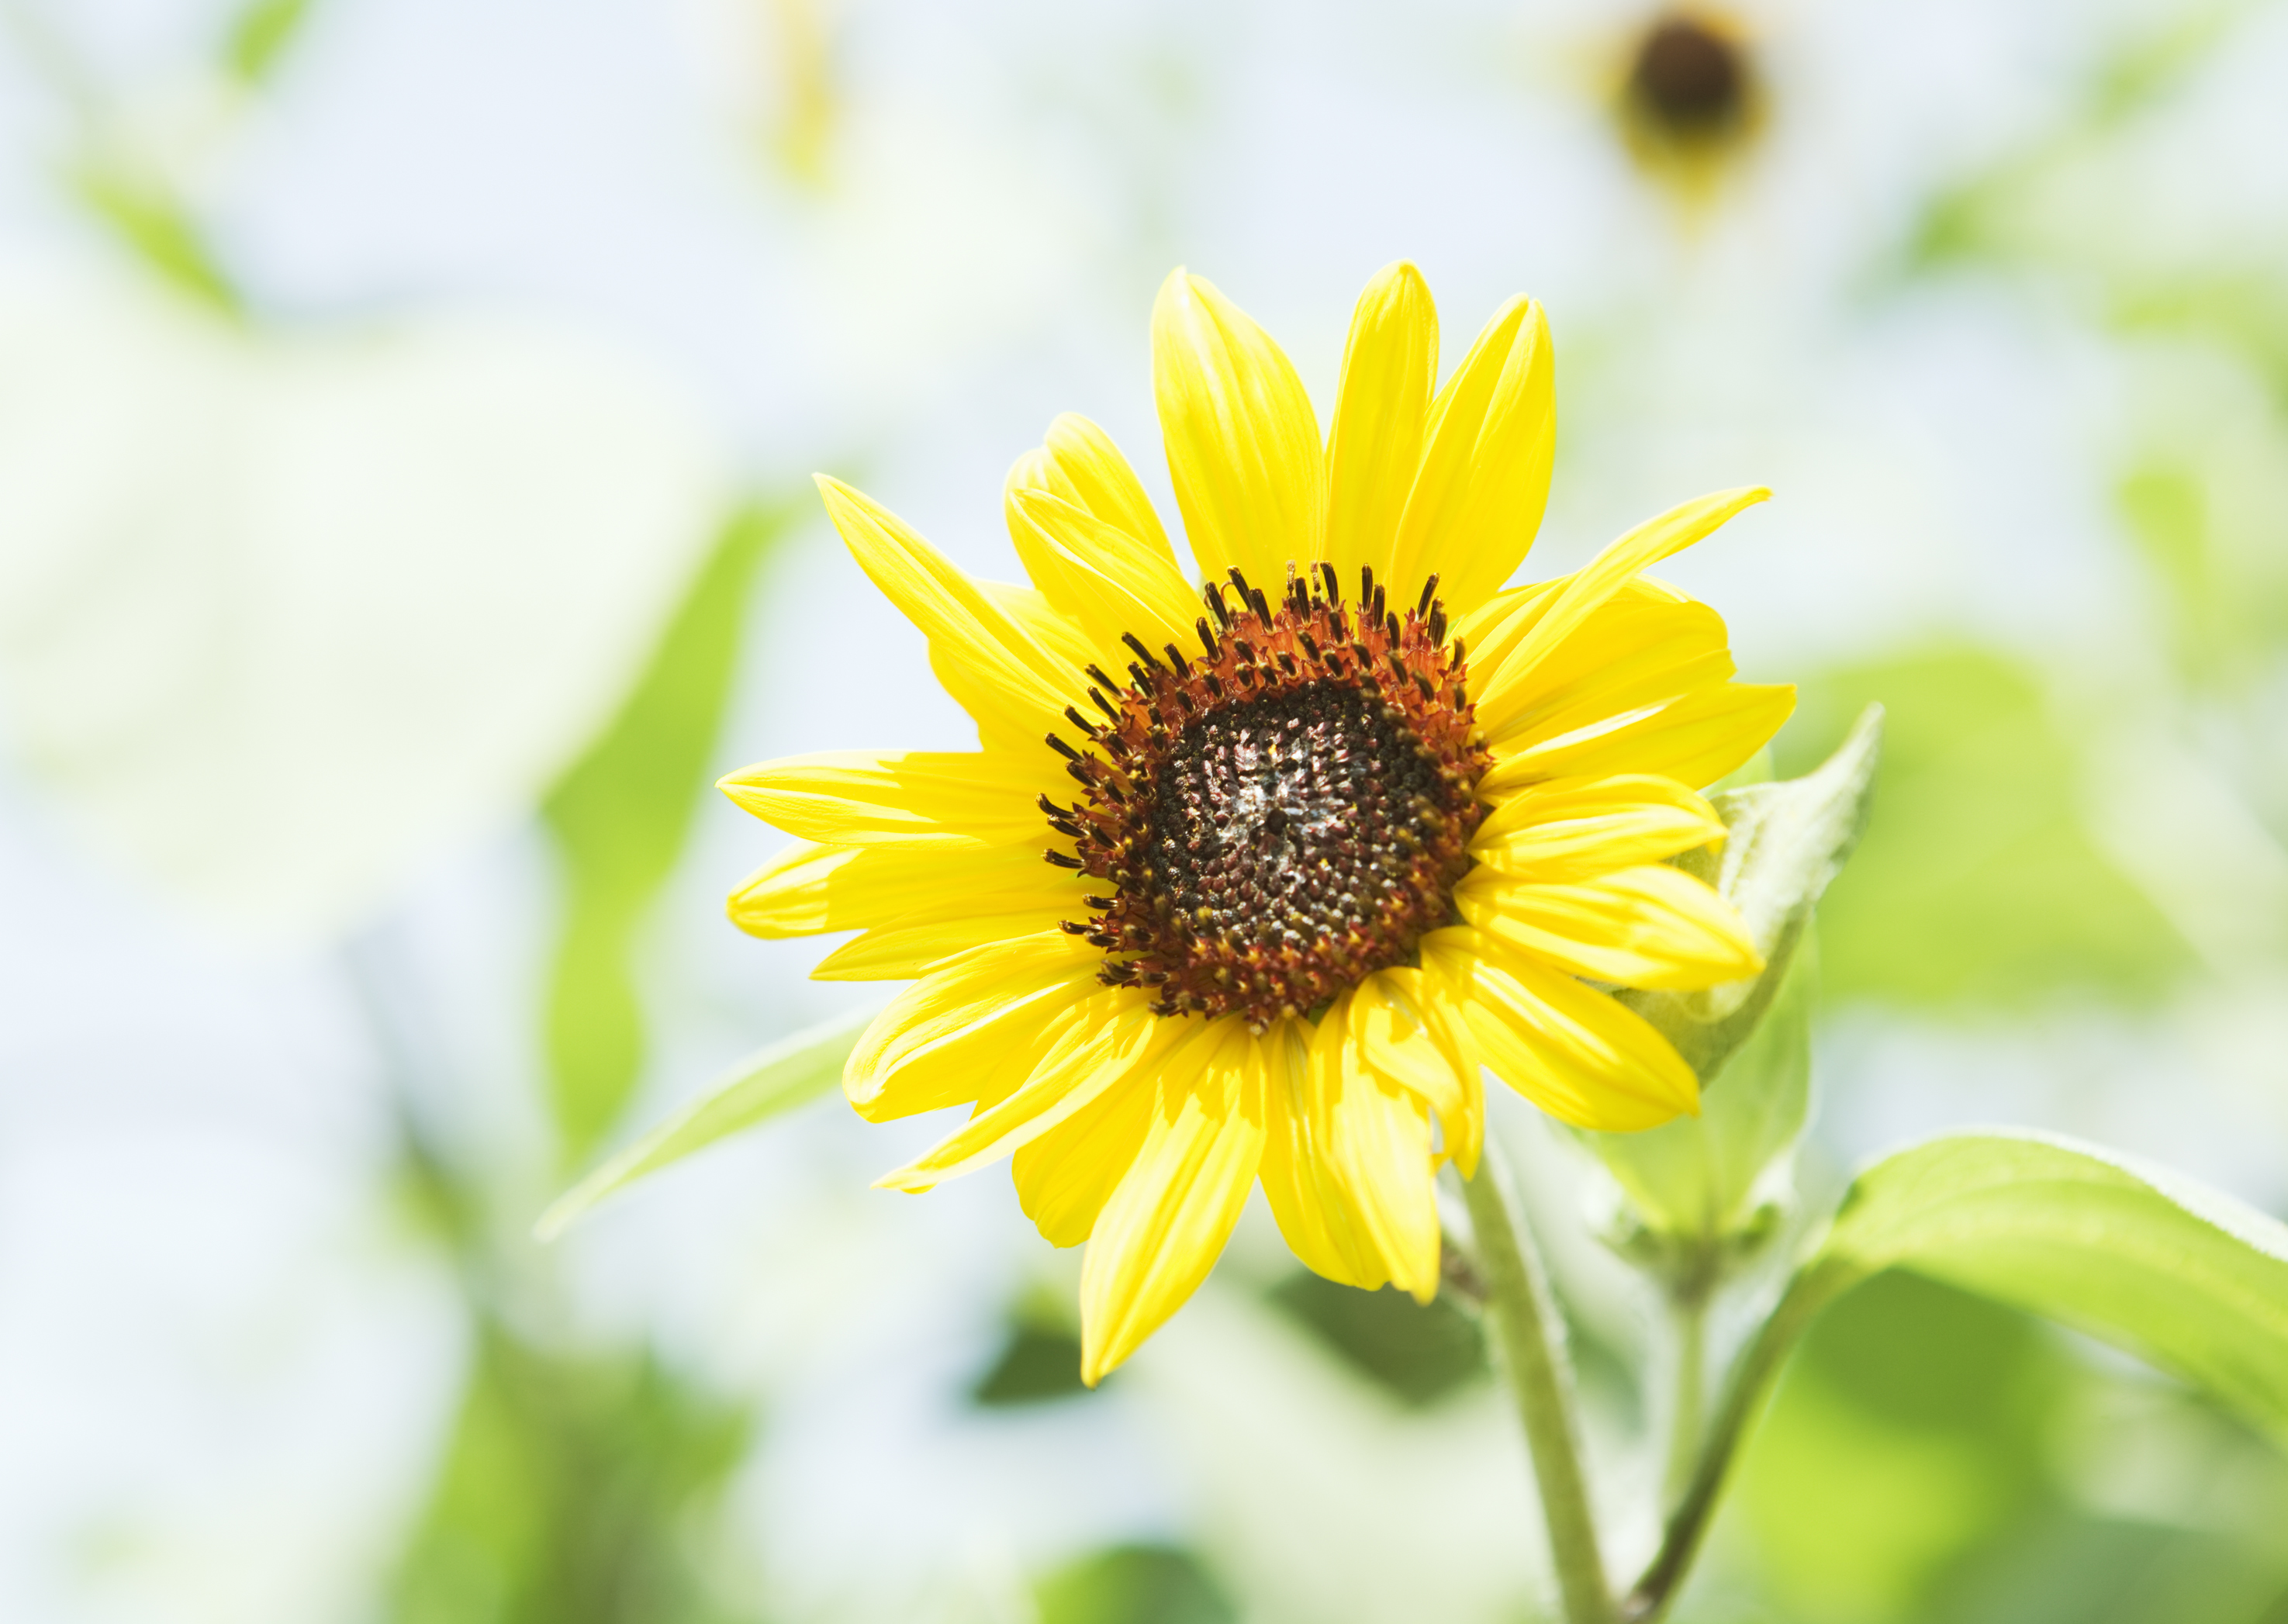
1391 297 1556 617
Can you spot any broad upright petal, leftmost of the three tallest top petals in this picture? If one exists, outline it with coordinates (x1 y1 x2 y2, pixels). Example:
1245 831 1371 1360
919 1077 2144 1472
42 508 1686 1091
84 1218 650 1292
1151 270 1327 595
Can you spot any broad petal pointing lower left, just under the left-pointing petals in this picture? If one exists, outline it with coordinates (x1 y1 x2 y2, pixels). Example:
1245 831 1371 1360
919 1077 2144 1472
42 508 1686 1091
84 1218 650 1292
842 931 1103 1123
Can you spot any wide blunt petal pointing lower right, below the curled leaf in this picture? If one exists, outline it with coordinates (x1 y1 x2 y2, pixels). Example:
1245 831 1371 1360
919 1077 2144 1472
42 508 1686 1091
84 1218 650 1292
1423 926 1700 1132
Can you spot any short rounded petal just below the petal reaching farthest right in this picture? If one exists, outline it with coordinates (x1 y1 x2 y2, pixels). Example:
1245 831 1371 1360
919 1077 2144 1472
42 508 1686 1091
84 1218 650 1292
1469 773 1725 883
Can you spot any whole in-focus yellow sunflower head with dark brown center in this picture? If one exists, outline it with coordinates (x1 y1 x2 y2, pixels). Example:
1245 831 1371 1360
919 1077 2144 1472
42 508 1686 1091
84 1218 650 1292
721 263 1794 1384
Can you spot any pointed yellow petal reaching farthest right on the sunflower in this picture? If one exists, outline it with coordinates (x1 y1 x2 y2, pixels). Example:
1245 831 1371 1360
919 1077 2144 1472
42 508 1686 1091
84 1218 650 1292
1478 682 1796 800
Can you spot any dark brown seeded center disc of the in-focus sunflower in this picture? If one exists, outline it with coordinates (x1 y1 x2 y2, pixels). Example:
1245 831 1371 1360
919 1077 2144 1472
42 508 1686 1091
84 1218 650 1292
1041 565 1485 1029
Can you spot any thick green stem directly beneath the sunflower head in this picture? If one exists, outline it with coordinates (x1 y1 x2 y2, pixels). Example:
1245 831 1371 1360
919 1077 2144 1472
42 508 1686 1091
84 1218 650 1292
1462 1142 1616 1624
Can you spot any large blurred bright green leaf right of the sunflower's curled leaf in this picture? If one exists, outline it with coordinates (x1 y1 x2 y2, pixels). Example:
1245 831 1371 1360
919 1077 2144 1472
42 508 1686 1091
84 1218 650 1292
1780 648 2192 1011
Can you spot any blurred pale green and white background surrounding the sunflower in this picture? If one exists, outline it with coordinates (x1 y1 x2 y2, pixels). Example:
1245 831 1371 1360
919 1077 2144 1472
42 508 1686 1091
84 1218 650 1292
0 0 2288 1624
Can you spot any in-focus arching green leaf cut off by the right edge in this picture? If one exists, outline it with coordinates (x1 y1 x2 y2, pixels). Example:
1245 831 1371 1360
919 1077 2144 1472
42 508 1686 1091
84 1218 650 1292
1789 1132 2288 1446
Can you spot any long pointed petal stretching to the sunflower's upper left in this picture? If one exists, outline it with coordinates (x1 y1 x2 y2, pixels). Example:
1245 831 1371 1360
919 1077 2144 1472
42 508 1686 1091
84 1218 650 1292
819 475 1071 739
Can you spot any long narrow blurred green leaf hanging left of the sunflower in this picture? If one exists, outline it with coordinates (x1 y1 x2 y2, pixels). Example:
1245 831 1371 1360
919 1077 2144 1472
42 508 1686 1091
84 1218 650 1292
542 508 787 1162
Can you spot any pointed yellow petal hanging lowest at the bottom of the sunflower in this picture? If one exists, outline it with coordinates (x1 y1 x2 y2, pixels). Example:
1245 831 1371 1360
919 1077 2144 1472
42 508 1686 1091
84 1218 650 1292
1080 1020 1263 1386
